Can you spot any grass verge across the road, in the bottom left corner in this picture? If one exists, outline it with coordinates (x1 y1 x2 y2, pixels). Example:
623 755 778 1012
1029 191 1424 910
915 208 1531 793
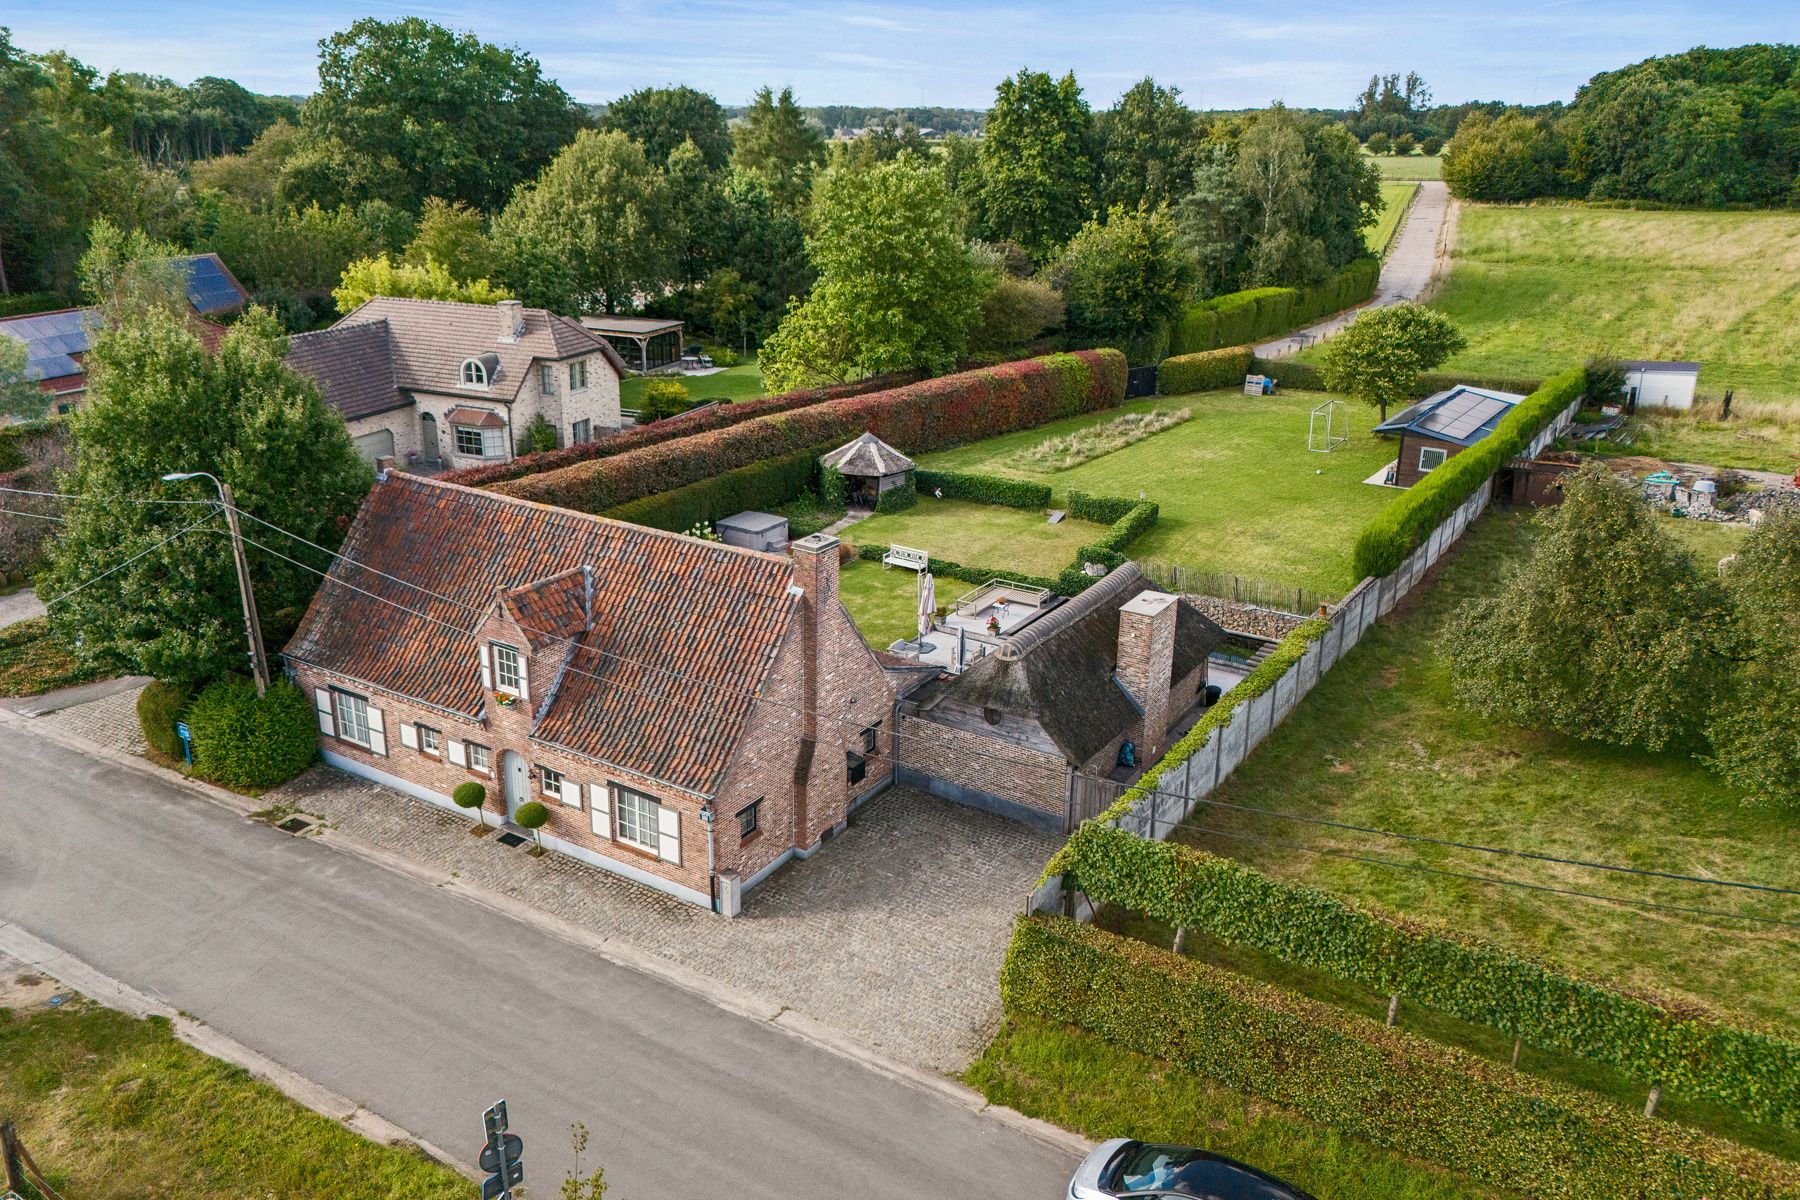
0 1000 473 1200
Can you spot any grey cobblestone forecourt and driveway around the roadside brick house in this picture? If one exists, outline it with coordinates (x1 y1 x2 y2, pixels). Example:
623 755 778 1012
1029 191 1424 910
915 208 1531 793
40 691 1060 1072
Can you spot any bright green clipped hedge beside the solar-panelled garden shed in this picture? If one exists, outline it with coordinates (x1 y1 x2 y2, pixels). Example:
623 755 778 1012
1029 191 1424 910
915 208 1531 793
1352 367 1588 579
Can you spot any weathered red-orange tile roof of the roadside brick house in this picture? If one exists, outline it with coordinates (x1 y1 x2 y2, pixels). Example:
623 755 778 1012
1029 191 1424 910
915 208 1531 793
286 473 794 795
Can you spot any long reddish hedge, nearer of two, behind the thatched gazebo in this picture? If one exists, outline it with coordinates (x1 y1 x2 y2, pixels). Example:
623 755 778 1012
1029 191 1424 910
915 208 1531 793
493 349 1125 513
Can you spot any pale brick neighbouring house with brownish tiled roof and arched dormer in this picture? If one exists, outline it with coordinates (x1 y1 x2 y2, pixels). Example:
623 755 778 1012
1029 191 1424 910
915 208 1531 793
288 295 625 470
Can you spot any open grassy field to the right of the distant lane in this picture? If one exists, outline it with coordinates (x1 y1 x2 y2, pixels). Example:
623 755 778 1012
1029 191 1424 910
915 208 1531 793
1433 205 1800 407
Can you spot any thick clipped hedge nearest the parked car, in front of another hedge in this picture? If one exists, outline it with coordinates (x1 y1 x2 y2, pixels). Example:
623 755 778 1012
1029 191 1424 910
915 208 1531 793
1001 918 1800 1200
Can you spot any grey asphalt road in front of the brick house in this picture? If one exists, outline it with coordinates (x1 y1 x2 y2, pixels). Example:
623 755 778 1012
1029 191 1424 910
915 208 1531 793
0 723 1073 1200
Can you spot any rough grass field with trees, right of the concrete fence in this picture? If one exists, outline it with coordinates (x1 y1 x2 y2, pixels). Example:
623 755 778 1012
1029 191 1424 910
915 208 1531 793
1181 513 1800 1036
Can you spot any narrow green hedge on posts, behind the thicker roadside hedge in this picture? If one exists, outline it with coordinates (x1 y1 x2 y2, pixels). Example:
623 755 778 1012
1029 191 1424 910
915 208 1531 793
1053 820 1800 1128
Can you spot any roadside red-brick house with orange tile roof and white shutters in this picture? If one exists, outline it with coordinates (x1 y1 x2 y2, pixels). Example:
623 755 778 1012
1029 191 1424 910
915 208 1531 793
284 471 893 916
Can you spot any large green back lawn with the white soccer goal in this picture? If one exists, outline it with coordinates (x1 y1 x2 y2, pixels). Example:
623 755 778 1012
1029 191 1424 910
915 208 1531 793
921 392 1399 596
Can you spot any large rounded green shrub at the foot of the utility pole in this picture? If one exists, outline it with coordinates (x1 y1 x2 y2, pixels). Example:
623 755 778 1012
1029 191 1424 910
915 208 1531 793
187 675 319 788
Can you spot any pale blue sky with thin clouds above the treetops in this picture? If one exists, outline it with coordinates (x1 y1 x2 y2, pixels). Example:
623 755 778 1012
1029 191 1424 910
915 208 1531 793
0 0 1796 108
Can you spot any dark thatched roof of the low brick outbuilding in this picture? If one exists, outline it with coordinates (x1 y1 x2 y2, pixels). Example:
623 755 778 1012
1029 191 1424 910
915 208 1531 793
943 563 1226 765
